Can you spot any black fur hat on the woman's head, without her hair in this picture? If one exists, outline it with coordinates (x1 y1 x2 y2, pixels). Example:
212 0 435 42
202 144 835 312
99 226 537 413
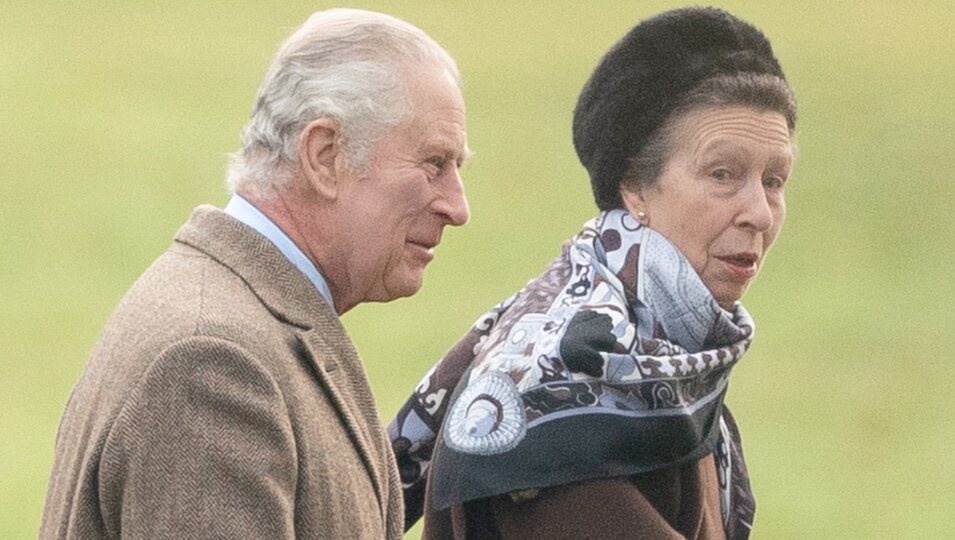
574 7 785 210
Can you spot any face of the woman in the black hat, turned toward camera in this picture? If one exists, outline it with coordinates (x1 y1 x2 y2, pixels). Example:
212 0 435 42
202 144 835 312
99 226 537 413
622 106 793 309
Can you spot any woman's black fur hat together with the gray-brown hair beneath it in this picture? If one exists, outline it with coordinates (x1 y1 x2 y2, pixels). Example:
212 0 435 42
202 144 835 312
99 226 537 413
573 7 796 210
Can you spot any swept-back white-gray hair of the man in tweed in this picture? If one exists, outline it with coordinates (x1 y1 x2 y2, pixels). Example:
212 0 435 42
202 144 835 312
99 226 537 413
226 9 460 199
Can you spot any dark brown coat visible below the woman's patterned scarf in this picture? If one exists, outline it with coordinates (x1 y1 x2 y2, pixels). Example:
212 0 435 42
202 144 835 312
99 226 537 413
422 454 725 540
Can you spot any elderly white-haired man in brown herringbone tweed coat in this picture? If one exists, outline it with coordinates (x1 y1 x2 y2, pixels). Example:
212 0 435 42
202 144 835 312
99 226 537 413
40 10 468 539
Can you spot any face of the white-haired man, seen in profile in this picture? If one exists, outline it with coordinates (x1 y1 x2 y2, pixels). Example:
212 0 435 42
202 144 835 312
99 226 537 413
328 69 469 308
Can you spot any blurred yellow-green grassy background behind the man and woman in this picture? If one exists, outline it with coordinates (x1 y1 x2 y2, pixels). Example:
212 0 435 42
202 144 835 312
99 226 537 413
0 0 955 539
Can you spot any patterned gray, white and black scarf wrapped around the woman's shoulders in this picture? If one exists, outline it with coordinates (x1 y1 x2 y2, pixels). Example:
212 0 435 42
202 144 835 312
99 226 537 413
388 210 755 538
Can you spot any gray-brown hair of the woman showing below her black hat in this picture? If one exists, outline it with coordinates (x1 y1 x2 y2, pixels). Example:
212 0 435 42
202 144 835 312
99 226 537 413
620 73 796 191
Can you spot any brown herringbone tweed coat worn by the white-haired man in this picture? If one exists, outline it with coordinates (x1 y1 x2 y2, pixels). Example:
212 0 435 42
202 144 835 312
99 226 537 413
40 206 403 540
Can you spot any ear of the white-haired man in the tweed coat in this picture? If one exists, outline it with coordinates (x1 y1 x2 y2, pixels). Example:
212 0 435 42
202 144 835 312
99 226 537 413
298 118 341 199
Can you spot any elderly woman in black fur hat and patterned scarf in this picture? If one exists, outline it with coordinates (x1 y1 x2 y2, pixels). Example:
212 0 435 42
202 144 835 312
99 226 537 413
390 8 796 539
